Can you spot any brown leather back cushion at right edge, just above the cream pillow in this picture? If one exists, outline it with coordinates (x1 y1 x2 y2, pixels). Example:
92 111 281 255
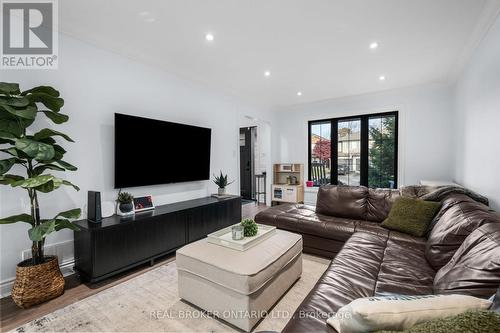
434 223 500 298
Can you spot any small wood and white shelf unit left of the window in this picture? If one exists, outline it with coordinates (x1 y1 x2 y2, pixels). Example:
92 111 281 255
271 163 304 205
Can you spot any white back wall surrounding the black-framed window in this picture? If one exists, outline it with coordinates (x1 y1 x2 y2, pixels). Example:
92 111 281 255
273 84 453 186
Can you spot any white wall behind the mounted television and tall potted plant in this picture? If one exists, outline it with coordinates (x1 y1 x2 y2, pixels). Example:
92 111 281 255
0 36 270 294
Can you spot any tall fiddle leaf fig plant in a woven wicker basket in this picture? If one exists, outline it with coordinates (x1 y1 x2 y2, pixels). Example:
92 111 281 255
0 82 81 308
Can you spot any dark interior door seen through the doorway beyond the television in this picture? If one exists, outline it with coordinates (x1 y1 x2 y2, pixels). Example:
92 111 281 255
240 127 252 200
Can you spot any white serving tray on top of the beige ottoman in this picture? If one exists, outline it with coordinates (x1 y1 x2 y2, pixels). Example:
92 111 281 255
207 224 276 251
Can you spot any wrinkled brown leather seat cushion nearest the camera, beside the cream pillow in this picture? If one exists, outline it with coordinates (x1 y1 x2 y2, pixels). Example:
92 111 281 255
283 232 435 332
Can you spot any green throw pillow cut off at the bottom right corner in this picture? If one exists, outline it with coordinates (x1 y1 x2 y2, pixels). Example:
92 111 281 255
377 310 500 333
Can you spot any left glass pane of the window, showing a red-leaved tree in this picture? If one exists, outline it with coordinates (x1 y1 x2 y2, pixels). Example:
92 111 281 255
310 121 332 186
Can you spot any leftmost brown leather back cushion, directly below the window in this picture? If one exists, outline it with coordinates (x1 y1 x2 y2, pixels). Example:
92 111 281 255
316 185 368 220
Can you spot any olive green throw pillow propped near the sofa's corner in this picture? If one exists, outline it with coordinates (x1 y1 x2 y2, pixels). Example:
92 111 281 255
382 198 441 237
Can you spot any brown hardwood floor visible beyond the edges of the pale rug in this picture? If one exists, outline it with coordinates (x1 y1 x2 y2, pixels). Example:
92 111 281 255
0 203 267 332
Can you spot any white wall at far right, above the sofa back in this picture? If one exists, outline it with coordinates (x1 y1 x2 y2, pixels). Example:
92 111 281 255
454 14 500 210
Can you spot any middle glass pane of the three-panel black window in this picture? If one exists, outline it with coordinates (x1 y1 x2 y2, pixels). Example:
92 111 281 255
336 119 361 186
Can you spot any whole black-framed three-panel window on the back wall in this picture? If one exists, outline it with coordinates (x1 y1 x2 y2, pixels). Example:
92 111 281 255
309 111 398 188
